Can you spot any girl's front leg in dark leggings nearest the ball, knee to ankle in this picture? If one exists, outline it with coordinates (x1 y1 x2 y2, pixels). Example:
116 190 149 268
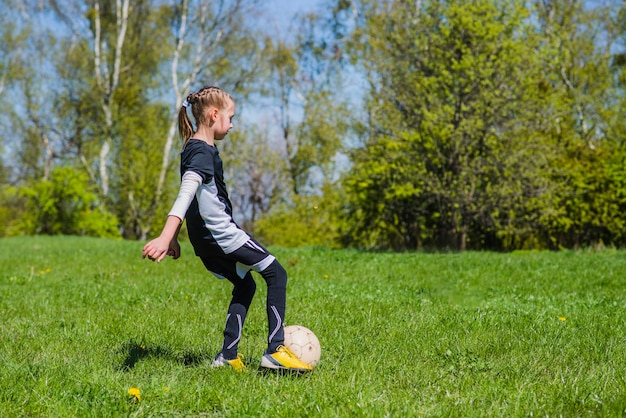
260 260 287 353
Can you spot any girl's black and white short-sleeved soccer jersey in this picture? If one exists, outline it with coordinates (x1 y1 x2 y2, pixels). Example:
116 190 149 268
180 139 250 257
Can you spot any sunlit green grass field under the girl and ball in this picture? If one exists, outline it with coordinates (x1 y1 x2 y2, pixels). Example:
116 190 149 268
0 237 626 417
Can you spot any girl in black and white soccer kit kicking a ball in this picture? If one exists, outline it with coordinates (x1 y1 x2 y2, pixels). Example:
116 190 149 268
143 87 311 371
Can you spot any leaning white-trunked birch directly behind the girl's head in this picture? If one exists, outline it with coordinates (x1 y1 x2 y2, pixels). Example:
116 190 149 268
154 0 258 209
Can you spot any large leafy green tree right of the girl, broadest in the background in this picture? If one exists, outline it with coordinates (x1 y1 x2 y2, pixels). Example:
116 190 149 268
338 1 545 250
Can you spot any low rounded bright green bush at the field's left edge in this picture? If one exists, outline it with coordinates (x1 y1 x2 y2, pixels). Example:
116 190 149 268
17 167 119 237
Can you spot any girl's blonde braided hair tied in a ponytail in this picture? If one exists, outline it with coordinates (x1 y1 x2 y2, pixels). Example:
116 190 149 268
178 86 235 144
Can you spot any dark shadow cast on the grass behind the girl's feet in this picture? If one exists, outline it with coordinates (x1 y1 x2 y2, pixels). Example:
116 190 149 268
119 341 212 371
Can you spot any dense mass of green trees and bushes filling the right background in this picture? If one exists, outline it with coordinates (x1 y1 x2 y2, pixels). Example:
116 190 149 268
338 1 626 250
